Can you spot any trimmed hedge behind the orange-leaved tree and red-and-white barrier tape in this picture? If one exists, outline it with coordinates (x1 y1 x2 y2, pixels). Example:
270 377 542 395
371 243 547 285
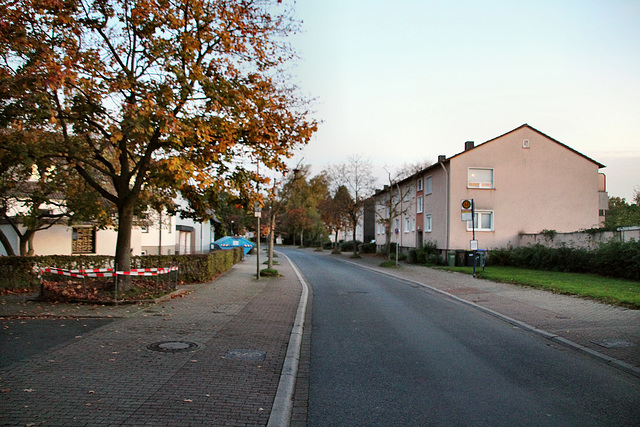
0 248 243 289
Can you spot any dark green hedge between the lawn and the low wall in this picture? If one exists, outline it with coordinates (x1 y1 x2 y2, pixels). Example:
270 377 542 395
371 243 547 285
487 240 640 280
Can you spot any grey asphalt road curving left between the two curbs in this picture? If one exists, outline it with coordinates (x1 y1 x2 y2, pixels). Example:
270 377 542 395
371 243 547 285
282 249 640 426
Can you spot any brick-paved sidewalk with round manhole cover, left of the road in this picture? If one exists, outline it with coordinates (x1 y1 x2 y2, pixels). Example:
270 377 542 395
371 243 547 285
0 256 301 426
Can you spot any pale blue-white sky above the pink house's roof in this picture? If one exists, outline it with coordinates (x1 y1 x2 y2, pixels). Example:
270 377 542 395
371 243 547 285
289 0 640 201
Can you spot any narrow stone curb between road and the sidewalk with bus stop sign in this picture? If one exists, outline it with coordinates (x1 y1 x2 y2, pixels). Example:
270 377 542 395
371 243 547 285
341 260 640 378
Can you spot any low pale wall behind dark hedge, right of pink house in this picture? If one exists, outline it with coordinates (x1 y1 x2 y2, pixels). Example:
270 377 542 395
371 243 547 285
518 226 640 249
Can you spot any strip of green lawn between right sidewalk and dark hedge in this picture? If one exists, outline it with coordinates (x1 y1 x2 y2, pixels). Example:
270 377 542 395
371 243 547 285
439 266 640 309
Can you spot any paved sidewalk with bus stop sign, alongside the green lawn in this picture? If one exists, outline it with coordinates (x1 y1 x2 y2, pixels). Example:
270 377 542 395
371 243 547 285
336 251 640 376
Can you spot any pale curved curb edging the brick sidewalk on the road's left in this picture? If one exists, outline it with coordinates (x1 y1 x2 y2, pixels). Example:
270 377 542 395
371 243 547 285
267 252 309 427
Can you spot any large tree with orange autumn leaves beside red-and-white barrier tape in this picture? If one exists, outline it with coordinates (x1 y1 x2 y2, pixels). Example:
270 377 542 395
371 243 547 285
0 0 316 290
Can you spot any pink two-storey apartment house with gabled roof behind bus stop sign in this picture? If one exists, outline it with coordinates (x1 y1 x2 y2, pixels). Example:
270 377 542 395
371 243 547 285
374 124 608 254
